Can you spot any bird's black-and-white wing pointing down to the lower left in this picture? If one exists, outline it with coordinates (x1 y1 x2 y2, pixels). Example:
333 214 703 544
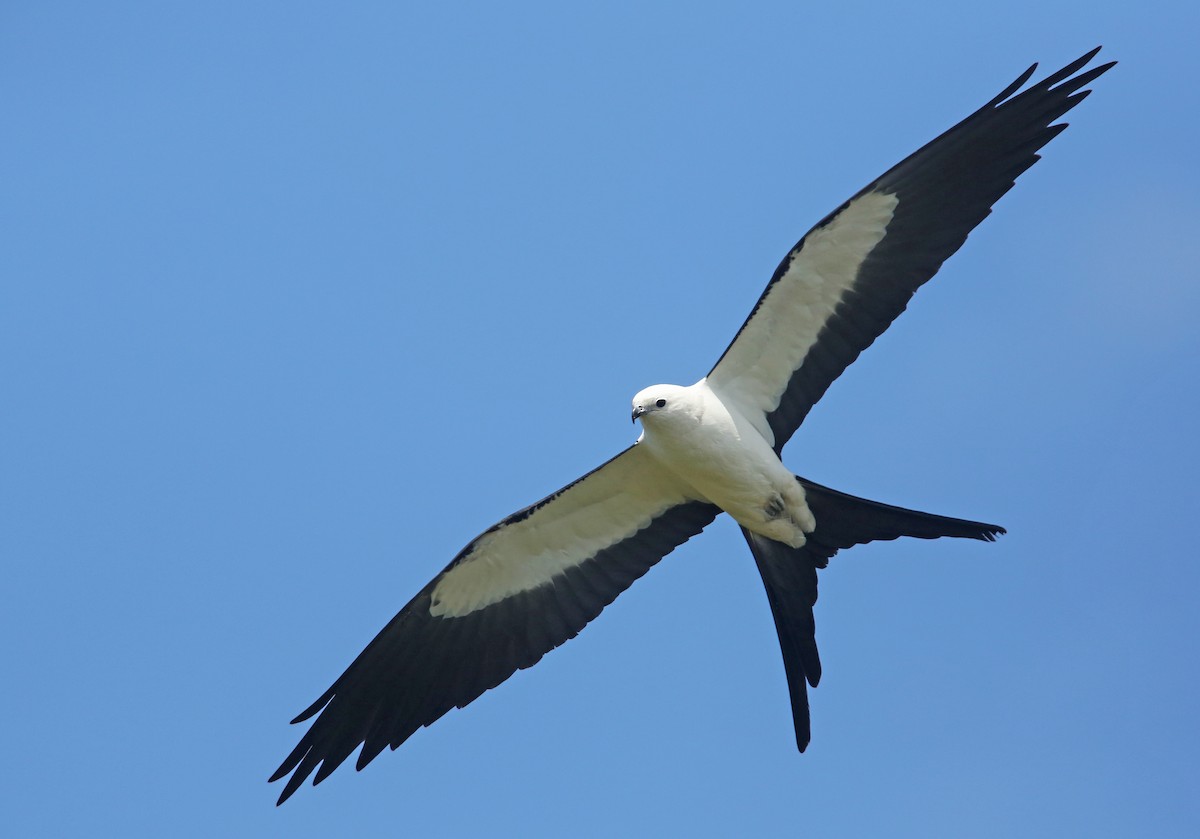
271 445 720 804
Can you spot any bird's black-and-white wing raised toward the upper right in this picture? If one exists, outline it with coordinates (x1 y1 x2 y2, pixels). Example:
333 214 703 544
708 47 1115 453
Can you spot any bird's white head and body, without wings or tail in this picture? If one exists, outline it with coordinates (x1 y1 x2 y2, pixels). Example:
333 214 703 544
634 378 816 547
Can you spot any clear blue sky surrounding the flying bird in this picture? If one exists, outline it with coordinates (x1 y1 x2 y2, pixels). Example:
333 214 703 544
0 0 1200 837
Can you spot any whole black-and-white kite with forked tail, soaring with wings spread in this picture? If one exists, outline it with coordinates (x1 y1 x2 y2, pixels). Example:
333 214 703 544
270 48 1115 804
